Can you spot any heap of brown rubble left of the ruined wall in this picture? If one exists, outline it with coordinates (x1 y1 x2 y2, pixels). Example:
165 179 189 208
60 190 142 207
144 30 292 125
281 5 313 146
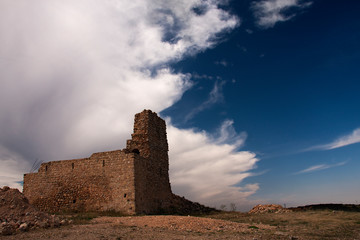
0 186 67 235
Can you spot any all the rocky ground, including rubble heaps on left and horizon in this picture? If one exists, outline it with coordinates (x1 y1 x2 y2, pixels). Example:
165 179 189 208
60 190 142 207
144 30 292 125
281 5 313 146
0 187 360 240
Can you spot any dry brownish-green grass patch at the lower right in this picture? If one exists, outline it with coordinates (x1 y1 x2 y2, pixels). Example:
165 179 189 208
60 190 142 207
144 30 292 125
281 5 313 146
207 210 360 239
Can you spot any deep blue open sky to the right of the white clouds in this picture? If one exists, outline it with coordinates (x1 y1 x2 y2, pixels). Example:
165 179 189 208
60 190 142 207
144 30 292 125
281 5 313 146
163 1 360 205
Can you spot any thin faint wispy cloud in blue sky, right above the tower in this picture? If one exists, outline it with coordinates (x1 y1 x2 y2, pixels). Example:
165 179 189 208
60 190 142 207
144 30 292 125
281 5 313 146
185 81 226 122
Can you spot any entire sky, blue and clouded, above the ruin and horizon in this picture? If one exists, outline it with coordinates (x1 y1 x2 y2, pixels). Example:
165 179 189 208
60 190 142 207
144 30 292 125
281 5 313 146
0 0 360 210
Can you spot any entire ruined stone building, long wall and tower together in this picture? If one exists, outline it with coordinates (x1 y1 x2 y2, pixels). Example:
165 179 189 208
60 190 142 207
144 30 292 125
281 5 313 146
23 110 214 214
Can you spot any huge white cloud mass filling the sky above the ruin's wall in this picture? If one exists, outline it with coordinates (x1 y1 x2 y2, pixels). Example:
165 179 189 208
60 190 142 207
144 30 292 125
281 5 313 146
0 0 239 159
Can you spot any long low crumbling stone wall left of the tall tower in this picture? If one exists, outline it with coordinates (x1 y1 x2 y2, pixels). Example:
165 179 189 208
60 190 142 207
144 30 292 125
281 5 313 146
23 150 139 214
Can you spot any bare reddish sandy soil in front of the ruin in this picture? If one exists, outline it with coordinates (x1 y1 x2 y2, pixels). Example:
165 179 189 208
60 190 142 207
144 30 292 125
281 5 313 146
1 216 276 240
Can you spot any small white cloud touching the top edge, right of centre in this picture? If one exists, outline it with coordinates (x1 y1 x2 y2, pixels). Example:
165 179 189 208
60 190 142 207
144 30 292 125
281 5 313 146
252 0 312 28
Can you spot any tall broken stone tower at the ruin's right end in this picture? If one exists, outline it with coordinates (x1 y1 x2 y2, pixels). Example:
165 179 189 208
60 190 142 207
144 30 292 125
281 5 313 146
126 110 172 212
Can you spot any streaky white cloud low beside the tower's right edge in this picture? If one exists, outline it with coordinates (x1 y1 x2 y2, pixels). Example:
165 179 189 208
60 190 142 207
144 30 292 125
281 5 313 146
168 121 259 206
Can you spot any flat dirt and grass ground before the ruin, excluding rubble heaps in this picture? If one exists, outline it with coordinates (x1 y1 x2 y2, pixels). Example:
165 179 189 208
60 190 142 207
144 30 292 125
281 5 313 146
0 210 360 240
